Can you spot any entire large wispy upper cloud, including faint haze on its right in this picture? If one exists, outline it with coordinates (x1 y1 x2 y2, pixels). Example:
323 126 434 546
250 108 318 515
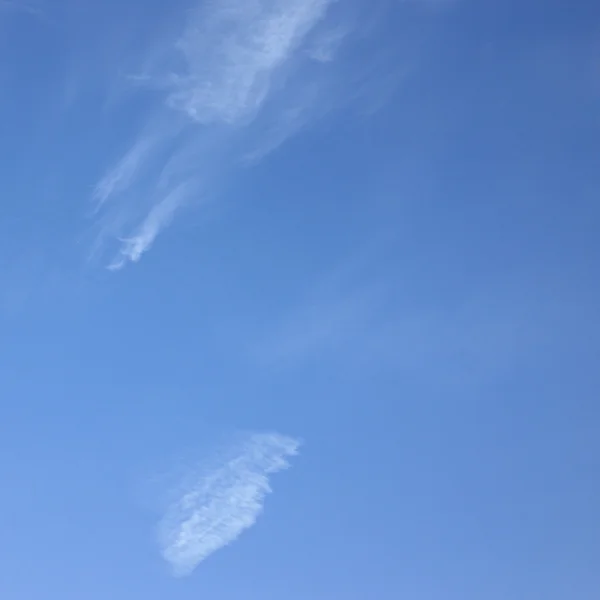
92 0 414 270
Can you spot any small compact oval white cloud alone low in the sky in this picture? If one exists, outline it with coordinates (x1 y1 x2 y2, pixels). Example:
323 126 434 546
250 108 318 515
159 434 300 576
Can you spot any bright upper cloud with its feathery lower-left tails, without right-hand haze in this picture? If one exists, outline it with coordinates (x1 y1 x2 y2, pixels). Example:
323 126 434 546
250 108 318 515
92 0 341 269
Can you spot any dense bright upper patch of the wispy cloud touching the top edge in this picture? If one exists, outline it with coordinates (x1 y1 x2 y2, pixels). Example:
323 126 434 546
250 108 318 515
167 0 330 124
